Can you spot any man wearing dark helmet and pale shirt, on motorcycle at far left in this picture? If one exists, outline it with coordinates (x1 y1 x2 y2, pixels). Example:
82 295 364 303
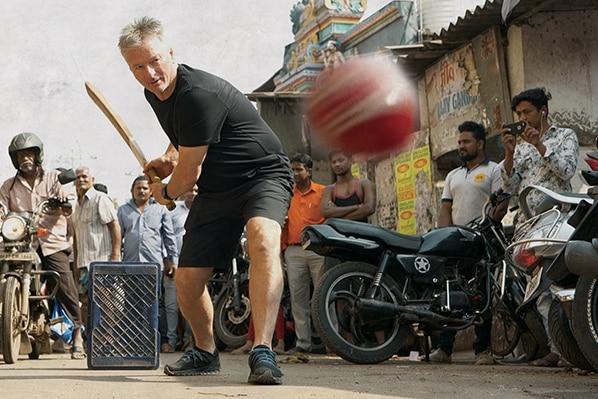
0 133 85 359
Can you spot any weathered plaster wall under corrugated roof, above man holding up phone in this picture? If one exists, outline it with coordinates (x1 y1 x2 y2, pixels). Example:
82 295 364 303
506 11 598 145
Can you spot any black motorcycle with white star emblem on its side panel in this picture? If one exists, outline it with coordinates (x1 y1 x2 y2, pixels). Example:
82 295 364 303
301 192 508 364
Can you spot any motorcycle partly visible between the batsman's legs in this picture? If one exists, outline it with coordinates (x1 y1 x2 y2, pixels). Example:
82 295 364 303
210 233 251 350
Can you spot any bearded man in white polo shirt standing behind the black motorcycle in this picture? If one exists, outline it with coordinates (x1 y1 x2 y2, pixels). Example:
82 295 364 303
430 121 502 365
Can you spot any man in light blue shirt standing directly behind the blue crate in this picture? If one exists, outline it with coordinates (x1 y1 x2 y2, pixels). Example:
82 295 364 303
117 176 179 352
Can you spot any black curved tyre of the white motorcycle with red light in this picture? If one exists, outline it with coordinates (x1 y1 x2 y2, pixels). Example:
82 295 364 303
548 300 594 371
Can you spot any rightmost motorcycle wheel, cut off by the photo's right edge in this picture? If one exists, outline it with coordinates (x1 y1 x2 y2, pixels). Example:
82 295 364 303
573 276 598 370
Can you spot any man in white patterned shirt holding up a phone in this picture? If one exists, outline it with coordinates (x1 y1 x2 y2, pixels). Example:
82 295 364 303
500 88 579 367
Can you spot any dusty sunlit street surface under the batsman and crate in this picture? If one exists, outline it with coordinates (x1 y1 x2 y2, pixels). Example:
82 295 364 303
0 352 598 399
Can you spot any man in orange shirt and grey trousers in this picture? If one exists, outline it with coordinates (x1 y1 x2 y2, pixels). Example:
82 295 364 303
281 154 325 353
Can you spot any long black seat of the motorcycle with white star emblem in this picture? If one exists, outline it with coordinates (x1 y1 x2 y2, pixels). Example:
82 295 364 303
324 218 423 251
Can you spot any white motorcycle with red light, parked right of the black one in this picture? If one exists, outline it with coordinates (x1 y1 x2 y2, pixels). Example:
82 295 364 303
508 181 594 370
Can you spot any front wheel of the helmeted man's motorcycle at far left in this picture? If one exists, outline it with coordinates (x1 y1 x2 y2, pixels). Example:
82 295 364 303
2 277 23 364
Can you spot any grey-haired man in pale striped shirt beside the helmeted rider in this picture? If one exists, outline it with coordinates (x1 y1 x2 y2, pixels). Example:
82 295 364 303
71 166 121 332
